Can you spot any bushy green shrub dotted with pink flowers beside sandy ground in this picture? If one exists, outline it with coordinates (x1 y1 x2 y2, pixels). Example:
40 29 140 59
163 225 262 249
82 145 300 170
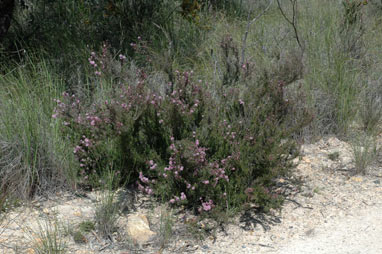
53 47 308 216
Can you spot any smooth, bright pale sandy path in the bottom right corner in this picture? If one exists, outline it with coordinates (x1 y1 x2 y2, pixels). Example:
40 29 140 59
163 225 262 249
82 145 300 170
274 204 382 254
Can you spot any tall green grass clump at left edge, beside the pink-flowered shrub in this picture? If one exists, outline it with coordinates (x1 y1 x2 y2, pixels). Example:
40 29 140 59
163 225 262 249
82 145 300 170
0 59 75 198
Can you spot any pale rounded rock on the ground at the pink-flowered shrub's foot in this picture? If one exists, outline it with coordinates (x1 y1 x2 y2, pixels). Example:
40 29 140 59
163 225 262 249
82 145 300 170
127 214 156 245
